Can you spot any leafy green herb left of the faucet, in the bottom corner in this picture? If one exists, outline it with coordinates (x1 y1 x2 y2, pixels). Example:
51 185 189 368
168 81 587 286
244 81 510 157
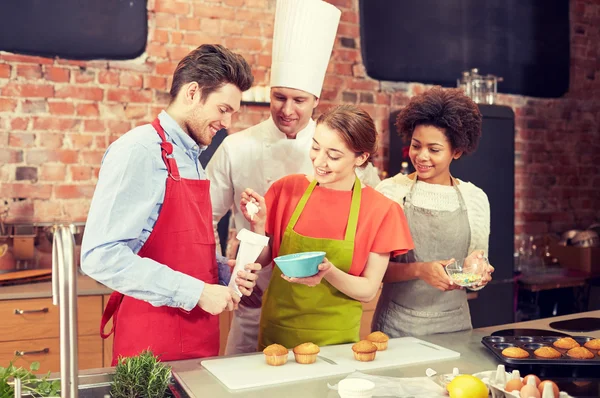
0 361 60 398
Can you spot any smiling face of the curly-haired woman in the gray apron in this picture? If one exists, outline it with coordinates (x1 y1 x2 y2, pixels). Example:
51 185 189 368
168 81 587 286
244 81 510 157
408 125 462 185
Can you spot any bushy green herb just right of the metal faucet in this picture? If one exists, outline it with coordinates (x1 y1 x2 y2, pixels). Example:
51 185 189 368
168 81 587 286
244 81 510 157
110 350 171 398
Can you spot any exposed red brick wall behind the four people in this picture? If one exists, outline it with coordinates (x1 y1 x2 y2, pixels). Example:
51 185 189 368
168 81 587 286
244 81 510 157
0 0 600 233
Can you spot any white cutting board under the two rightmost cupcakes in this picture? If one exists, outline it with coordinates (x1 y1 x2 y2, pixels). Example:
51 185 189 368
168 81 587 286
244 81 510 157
319 337 460 370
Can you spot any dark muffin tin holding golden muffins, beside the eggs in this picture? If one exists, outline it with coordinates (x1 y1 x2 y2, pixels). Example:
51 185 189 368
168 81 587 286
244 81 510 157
481 336 600 366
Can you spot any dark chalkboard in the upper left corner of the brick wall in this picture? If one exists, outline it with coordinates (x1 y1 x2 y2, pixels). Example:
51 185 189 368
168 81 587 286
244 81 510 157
0 0 148 60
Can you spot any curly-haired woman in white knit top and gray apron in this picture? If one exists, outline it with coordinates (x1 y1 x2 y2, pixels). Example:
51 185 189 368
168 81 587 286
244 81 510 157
372 87 494 337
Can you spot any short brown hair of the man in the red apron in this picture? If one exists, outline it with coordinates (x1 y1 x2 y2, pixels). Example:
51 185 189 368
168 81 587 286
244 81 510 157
170 44 254 101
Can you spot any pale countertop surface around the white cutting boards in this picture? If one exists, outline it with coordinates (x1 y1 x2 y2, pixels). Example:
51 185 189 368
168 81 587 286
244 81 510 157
172 311 600 398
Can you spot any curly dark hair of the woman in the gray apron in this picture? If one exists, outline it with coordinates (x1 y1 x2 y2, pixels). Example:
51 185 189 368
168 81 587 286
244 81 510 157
396 87 481 154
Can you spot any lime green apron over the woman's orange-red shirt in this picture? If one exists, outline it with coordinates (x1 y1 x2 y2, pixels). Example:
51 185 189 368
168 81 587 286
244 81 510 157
258 178 362 350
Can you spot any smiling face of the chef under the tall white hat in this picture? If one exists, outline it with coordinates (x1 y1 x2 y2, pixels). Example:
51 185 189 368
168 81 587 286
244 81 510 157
271 87 319 138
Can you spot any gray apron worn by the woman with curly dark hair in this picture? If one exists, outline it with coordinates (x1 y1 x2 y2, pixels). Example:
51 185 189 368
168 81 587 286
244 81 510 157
372 182 472 337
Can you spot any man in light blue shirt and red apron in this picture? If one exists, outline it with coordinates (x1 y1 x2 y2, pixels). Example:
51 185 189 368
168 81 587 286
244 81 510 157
81 45 260 365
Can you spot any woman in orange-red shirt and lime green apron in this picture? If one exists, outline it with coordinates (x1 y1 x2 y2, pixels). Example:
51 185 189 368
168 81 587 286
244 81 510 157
241 105 412 349
